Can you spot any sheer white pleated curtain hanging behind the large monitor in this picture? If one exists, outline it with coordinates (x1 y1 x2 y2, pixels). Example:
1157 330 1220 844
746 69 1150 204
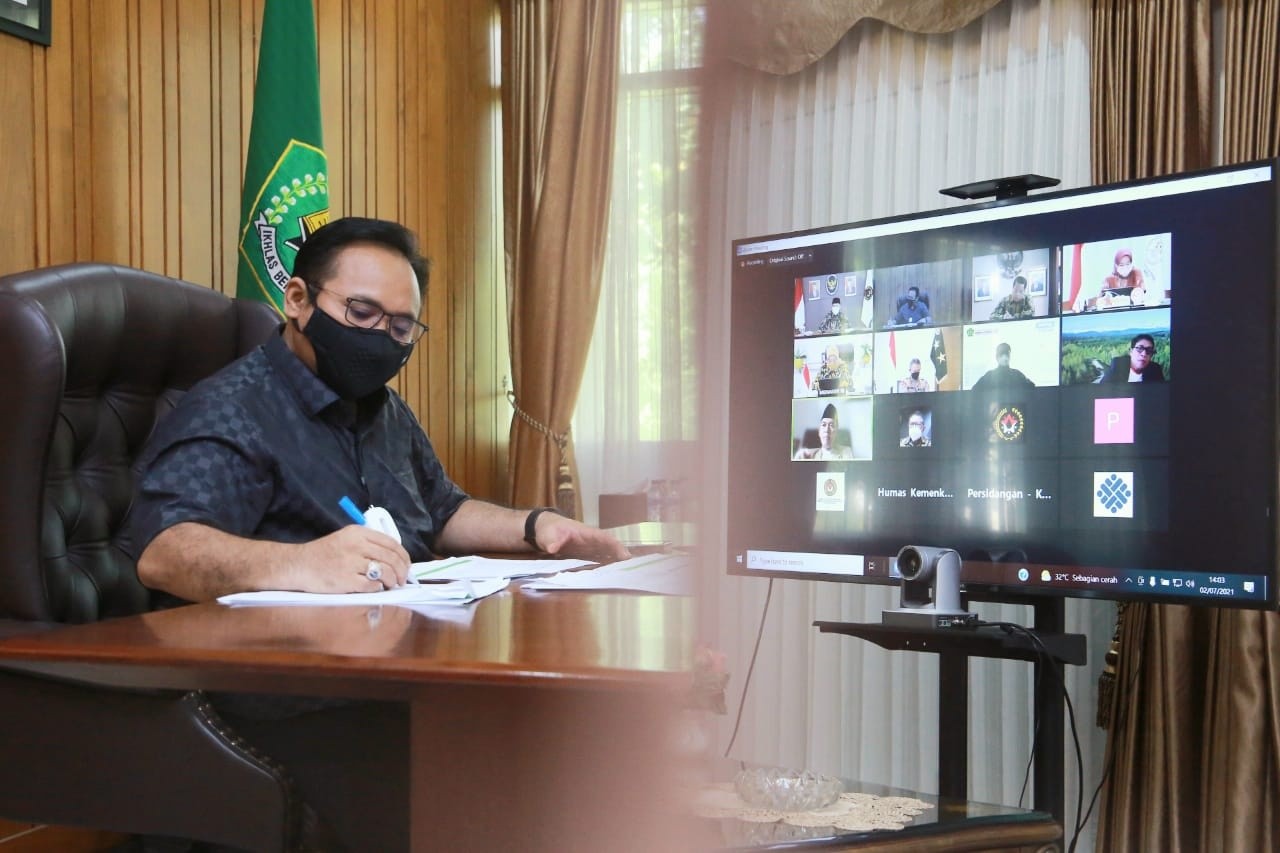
703 0 1114 847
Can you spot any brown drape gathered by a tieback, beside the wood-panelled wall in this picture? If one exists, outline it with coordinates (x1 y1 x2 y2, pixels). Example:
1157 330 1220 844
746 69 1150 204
502 0 620 517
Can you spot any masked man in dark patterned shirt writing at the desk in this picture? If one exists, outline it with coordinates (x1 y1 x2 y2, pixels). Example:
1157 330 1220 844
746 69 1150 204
122 218 626 849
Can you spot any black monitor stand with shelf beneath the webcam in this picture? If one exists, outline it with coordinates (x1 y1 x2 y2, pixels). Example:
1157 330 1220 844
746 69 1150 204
814 596 1087 827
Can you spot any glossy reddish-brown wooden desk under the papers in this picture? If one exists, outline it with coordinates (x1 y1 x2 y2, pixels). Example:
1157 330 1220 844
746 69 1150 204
0 588 694 850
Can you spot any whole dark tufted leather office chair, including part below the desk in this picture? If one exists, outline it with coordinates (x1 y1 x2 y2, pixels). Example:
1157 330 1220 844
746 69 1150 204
0 264 314 850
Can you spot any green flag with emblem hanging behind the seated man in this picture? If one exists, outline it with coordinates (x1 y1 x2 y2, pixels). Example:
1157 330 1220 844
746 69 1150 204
236 0 329 313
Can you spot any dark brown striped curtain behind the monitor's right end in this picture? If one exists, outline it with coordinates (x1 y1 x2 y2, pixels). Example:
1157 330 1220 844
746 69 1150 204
1091 0 1280 853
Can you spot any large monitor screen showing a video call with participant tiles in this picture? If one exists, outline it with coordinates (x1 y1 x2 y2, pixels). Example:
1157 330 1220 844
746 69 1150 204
726 161 1280 607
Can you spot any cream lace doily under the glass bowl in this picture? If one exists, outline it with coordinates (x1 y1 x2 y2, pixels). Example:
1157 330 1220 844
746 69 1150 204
692 783 933 833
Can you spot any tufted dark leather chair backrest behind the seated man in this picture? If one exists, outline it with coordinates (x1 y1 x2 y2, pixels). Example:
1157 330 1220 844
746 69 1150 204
0 264 279 622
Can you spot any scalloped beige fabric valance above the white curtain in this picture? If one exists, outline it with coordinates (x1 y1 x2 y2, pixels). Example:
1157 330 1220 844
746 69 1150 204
712 0 1000 74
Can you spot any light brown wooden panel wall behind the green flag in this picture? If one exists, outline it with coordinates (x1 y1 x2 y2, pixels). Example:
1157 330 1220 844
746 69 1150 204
0 0 511 498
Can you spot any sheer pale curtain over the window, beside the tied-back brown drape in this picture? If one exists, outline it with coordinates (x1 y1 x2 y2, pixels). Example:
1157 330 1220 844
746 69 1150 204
573 0 703 521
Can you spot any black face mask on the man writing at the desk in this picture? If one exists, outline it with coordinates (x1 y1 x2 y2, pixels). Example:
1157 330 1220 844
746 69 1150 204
302 306 413 400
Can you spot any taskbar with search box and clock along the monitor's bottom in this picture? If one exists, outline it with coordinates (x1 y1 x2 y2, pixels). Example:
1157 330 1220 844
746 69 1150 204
736 548 1268 603
